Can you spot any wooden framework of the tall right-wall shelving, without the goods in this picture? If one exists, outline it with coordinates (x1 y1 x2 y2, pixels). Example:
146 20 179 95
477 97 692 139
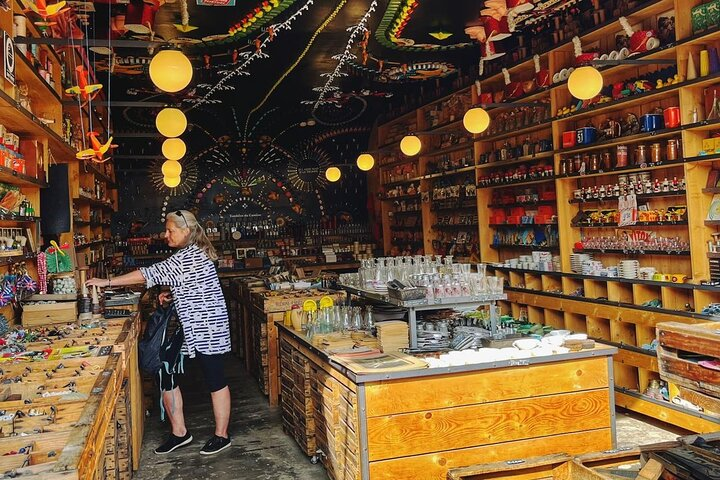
377 0 720 431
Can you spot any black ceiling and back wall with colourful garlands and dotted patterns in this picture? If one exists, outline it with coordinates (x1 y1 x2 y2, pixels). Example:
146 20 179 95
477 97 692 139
37 0 617 231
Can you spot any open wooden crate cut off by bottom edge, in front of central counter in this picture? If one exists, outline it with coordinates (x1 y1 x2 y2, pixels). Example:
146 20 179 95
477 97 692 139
447 453 606 480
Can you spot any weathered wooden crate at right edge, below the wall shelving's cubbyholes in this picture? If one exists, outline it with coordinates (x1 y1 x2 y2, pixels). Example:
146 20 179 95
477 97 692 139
657 322 720 398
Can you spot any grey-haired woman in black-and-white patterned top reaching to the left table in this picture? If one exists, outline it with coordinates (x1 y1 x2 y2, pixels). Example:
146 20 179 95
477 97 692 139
87 210 231 455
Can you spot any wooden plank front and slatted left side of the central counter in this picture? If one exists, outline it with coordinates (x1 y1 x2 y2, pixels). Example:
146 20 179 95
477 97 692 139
276 323 617 480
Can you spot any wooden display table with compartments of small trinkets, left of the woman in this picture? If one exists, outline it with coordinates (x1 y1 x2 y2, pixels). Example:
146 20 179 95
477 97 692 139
0 314 144 480
